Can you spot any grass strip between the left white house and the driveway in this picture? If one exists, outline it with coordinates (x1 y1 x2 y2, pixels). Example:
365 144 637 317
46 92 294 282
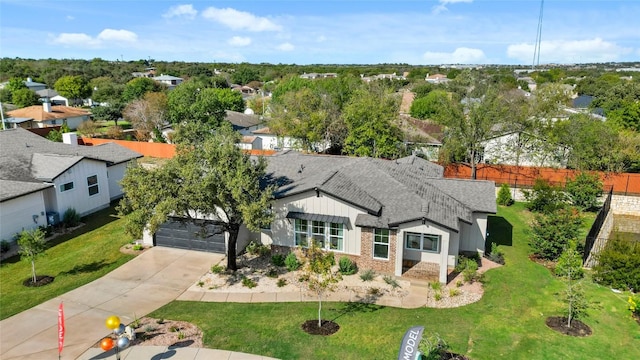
0 207 133 319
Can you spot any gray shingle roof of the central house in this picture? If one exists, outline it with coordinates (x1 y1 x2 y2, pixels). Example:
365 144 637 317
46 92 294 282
267 151 495 231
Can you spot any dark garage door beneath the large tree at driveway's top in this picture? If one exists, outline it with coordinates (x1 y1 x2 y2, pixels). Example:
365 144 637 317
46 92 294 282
154 218 226 254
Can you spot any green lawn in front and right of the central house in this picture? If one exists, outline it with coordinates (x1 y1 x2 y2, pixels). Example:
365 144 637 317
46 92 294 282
149 203 640 360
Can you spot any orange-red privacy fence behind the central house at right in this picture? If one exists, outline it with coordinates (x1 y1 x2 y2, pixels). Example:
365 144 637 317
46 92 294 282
444 164 640 195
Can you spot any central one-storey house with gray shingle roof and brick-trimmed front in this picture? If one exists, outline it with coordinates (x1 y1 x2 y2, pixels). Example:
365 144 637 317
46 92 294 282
260 152 496 283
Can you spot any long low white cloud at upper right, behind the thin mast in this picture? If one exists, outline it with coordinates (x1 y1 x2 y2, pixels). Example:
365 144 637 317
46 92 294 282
507 37 633 63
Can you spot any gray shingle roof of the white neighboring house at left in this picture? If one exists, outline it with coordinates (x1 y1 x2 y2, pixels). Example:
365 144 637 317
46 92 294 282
0 128 142 197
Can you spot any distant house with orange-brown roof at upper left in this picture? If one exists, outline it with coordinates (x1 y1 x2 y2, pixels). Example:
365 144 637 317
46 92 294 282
7 102 91 130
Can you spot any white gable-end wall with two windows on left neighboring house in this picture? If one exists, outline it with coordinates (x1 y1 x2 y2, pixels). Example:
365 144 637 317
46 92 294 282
47 159 110 219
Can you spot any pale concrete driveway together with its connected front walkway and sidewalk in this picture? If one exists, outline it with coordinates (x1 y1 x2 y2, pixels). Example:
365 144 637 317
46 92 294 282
0 247 426 360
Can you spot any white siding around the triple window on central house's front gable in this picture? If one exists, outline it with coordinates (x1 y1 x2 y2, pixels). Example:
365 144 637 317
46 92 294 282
262 191 365 255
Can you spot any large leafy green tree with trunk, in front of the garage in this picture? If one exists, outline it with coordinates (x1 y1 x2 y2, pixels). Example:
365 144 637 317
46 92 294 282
120 126 274 270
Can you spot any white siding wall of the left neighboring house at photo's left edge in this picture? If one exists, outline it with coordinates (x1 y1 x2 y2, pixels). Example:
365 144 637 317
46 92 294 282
0 191 47 241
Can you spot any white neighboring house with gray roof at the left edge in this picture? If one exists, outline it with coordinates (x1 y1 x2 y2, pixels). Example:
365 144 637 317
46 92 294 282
0 128 142 240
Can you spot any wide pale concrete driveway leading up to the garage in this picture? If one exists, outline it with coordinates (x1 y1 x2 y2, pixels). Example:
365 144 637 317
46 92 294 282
0 247 224 360
